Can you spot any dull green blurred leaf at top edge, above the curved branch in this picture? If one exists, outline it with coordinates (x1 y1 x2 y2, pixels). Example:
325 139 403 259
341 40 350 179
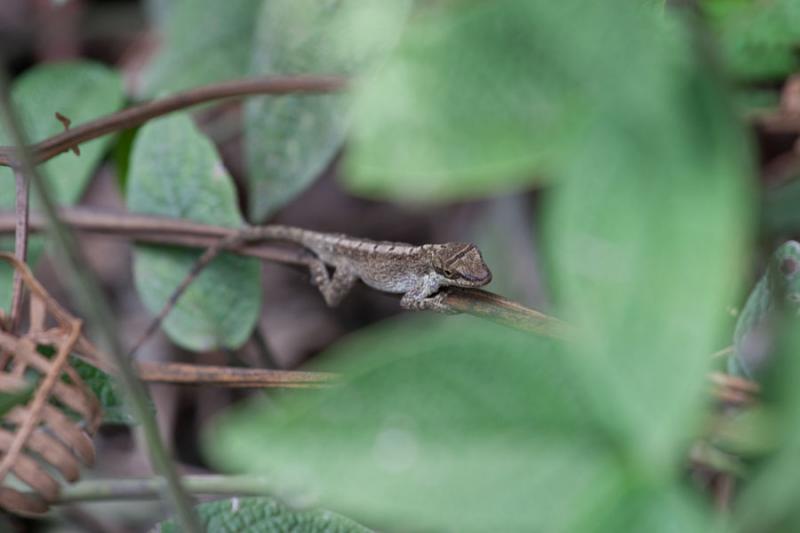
138 0 261 96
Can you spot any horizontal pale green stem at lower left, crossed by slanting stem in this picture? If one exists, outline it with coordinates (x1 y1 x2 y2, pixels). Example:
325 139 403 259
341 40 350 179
53 475 275 504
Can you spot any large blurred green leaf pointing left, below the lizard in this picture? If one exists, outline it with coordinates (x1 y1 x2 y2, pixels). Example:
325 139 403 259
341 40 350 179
206 319 622 531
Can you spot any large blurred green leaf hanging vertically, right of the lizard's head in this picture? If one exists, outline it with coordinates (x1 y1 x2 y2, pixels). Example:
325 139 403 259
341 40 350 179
547 65 751 470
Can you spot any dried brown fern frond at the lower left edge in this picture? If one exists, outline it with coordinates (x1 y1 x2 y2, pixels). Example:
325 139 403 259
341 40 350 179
0 253 101 514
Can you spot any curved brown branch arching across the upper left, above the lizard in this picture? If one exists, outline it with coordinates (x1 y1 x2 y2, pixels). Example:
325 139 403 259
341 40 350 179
0 76 346 166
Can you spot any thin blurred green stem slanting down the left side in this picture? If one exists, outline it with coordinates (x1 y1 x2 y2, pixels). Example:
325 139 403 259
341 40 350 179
0 68 202 532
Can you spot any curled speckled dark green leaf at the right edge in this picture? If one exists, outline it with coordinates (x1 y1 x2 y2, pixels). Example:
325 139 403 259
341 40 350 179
728 241 800 379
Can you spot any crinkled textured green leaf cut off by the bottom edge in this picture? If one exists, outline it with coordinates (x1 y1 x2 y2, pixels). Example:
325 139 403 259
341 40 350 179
159 497 370 533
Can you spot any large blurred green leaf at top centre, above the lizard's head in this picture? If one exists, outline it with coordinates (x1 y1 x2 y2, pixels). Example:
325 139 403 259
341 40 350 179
346 0 680 200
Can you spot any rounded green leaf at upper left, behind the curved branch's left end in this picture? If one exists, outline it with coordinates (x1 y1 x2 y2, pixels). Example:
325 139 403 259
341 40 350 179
0 61 124 308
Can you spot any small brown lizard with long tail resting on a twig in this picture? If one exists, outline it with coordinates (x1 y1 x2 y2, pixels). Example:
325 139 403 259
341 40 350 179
129 225 492 354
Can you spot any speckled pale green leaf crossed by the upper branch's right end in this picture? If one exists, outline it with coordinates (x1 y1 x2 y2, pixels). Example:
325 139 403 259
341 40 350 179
245 0 410 220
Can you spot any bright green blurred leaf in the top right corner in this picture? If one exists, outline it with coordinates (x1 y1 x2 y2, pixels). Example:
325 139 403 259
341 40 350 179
700 0 800 79
